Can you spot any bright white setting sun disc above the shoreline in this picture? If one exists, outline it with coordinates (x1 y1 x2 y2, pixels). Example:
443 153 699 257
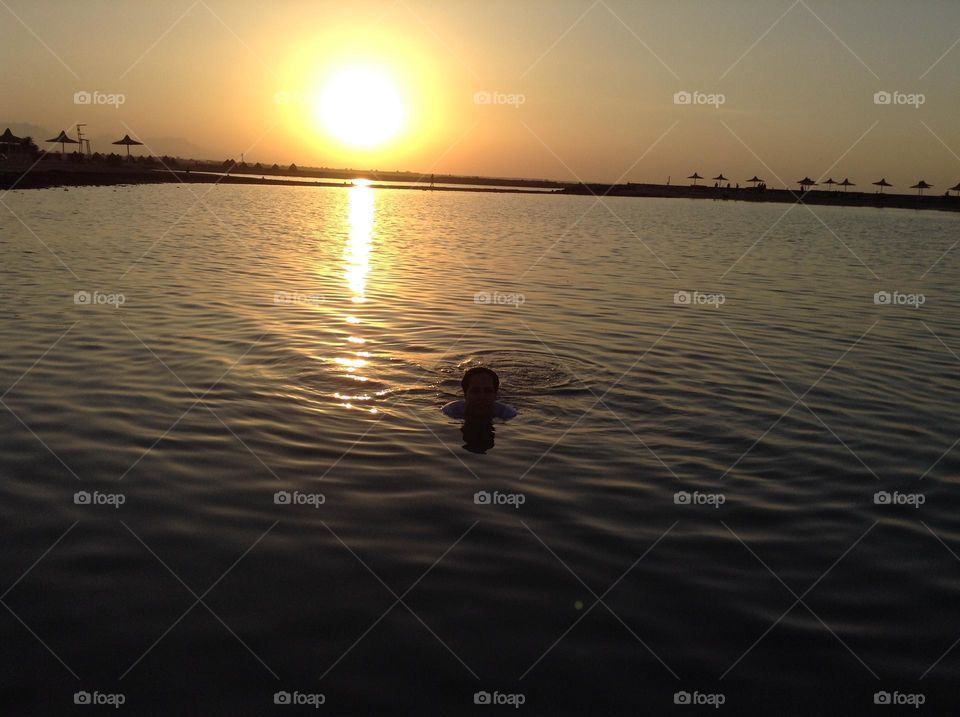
314 66 406 149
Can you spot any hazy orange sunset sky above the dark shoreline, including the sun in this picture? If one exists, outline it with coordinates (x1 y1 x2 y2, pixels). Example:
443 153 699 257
0 0 960 191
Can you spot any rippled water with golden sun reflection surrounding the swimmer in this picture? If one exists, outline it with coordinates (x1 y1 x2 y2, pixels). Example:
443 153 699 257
0 186 960 714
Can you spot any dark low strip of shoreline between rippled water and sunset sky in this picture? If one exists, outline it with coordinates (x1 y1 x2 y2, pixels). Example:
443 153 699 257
0 167 960 212
